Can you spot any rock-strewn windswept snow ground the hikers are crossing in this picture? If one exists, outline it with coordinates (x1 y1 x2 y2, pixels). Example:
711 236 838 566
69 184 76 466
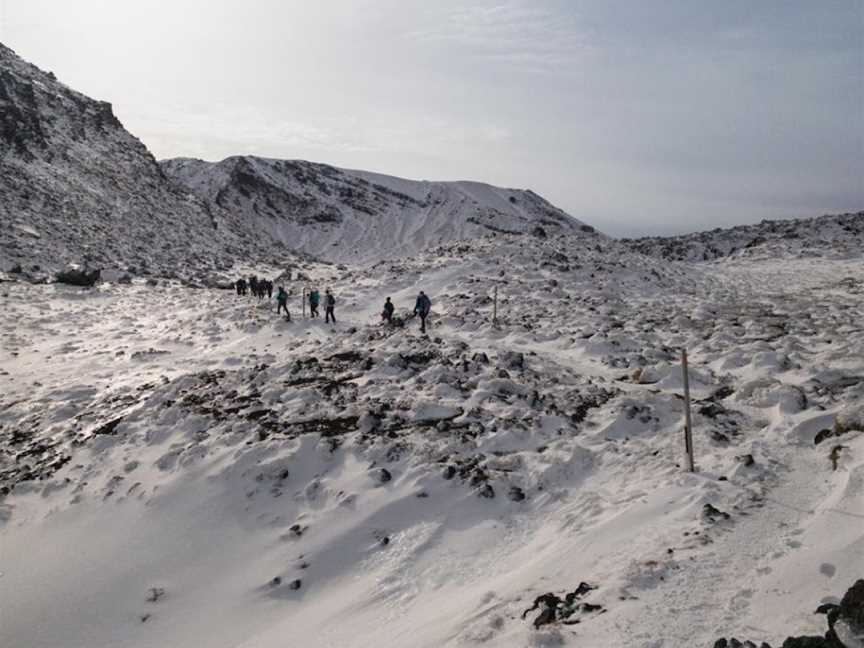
0 235 864 648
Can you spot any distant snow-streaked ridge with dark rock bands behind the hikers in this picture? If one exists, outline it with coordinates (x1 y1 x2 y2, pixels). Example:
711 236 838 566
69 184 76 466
161 156 593 263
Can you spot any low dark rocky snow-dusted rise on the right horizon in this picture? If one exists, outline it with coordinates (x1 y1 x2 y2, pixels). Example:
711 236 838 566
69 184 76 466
624 212 864 261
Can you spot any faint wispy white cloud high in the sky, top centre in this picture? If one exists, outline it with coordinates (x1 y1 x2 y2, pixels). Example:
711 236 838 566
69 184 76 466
406 0 590 72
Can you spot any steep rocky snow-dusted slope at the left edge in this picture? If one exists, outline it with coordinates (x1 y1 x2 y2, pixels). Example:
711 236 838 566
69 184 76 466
0 44 296 279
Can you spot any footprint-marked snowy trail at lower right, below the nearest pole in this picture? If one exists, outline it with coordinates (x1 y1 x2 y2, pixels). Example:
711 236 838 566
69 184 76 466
615 428 864 648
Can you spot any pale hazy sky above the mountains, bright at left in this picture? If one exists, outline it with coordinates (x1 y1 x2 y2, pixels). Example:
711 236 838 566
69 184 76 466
0 0 864 235
